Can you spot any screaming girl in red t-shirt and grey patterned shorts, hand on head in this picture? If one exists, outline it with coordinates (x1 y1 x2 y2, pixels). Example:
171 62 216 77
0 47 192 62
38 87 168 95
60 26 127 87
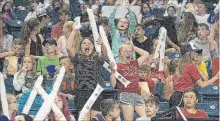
110 40 149 121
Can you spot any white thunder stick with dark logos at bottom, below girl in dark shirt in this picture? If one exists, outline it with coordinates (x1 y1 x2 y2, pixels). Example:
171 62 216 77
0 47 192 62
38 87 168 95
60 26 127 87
78 84 104 121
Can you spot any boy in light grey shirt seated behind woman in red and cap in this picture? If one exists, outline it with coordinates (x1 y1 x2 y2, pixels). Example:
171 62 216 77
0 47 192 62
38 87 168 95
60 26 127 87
190 23 217 61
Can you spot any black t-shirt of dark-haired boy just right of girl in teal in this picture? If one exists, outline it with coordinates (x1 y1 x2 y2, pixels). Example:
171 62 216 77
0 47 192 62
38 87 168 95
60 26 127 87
133 38 153 58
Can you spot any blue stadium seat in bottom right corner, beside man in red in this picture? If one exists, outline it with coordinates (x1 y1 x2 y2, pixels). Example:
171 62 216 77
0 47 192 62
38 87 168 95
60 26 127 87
196 102 219 117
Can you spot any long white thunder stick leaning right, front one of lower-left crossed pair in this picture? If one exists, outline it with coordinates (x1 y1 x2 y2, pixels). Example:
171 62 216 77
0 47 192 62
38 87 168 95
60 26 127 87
34 67 65 121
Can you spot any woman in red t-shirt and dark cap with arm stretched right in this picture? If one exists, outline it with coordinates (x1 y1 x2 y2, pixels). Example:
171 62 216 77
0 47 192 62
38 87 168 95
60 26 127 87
170 44 219 107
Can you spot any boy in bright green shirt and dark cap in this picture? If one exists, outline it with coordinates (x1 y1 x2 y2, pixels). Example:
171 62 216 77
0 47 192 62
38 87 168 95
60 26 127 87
37 38 59 77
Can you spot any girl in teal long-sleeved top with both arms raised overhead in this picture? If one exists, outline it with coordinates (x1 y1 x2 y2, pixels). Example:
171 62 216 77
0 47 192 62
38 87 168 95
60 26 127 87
109 2 136 61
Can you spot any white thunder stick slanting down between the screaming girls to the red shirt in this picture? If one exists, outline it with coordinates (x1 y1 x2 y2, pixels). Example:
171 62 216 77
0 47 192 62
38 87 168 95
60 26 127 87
99 26 131 87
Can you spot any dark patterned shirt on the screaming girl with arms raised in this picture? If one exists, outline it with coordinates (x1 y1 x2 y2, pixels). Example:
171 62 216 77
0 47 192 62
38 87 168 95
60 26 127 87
71 54 104 90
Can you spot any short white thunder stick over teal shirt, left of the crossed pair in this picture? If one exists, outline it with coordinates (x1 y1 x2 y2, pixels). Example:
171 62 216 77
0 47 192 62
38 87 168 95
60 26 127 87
22 76 43 114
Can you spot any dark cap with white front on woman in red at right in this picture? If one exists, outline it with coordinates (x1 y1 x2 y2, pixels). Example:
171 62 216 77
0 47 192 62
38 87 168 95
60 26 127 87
180 44 202 55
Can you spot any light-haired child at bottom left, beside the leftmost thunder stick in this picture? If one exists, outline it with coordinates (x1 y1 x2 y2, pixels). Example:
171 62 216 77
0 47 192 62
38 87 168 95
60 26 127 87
6 94 18 121
